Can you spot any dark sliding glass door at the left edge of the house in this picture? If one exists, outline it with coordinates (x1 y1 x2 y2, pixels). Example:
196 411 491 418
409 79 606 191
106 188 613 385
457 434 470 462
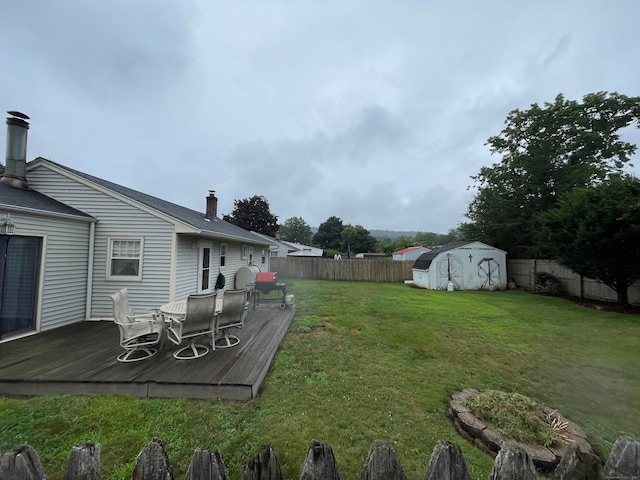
0 235 42 338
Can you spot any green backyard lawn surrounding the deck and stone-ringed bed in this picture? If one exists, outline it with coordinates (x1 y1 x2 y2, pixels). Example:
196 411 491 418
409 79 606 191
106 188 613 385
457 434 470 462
0 280 640 480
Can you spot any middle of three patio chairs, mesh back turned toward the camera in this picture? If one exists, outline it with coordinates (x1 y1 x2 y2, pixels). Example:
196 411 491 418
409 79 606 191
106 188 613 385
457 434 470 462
167 293 216 360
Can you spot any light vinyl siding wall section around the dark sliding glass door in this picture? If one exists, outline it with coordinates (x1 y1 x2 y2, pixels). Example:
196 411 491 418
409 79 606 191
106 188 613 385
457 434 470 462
6 213 90 331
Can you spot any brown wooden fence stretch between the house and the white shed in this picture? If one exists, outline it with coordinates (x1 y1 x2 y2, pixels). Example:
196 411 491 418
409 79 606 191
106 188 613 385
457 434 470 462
270 257 415 283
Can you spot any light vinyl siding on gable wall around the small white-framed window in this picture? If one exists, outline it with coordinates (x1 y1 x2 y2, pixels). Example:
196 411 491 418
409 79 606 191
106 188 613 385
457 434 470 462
29 167 174 318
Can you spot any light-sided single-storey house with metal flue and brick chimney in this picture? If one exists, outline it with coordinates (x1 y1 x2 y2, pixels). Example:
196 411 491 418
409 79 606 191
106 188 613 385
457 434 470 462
0 112 269 341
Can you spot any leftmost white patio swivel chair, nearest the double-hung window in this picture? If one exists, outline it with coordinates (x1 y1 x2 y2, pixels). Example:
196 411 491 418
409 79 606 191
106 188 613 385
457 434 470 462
110 288 164 363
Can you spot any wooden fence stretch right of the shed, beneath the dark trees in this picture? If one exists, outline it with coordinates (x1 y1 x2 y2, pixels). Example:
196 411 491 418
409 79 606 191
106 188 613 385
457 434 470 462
507 259 640 305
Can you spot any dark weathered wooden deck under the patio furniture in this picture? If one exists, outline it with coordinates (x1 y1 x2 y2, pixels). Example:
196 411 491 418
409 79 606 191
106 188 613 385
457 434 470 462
0 302 295 400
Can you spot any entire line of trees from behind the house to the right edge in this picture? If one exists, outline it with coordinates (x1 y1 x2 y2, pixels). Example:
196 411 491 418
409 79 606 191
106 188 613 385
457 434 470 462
224 92 640 305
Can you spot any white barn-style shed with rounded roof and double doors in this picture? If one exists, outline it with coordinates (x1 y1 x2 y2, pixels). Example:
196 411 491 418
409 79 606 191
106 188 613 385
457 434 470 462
412 242 507 290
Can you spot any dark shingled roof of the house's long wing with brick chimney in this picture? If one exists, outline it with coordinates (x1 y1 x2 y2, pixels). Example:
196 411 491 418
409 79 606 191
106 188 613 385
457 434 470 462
29 157 269 245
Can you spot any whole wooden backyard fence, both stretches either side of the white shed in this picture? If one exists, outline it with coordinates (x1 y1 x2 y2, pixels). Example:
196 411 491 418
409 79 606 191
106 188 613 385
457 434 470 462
271 257 640 305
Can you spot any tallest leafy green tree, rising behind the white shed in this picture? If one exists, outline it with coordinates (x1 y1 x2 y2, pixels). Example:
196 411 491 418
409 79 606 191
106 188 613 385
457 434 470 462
467 92 640 257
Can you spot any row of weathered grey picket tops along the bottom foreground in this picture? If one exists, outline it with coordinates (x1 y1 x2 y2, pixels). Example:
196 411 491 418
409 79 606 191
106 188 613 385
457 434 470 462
0 437 640 480
